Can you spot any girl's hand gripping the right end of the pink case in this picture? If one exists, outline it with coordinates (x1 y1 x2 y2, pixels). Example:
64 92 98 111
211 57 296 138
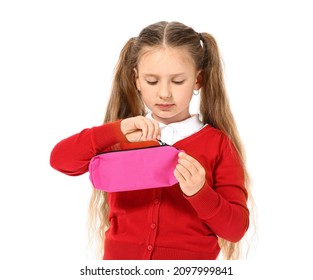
174 152 205 196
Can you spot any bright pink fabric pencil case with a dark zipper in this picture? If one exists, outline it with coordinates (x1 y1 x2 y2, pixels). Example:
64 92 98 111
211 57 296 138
89 145 180 192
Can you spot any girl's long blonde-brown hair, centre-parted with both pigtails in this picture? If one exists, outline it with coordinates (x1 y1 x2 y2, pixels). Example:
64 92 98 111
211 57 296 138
89 21 251 259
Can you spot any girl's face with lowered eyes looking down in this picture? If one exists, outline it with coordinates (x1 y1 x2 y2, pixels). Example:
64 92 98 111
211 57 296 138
135 48 201 124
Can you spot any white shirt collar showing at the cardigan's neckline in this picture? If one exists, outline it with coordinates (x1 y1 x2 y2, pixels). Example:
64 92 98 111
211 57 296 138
146 113 203 145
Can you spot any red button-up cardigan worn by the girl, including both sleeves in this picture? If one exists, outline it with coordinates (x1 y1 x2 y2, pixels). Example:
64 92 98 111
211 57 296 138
50 121 249 260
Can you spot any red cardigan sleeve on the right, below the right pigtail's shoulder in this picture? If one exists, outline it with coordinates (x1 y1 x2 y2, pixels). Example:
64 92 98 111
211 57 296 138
186 135 249 242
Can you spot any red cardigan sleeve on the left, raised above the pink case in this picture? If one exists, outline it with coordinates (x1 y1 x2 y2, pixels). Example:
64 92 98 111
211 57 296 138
50 120 126 176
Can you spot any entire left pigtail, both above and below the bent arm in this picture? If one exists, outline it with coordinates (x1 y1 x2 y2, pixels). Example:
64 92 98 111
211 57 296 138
88 38 145 259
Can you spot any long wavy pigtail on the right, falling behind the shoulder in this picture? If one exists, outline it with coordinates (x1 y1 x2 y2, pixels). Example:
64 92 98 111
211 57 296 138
199 33 254 259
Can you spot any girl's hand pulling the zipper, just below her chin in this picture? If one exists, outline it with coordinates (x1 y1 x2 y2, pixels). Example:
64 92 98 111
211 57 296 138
121 116 161 142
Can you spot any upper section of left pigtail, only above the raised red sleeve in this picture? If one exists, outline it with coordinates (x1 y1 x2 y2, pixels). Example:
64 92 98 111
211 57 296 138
104 38 144 123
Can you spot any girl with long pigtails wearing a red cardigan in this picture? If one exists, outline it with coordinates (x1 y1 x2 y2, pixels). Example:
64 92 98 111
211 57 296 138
50 22 249 260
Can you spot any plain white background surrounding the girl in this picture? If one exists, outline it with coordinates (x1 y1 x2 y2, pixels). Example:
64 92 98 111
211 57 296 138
0 0 313 279
